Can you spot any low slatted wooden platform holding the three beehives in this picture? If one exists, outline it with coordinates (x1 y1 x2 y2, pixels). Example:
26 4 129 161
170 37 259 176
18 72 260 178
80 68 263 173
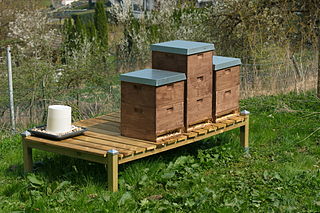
23 112 249 191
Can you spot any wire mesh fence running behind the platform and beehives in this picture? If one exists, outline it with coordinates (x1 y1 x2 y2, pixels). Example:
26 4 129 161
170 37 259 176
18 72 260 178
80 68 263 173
0 57 317 130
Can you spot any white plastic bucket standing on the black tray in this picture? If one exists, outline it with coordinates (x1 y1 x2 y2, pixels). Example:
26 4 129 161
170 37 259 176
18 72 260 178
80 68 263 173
46 105 72 134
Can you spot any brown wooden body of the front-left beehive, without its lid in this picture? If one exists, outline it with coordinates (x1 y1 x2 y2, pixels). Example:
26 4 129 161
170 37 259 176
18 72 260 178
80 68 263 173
120 78 185 141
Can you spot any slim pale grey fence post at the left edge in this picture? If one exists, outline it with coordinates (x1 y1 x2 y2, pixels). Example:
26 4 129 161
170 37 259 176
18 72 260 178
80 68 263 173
7 46 16 132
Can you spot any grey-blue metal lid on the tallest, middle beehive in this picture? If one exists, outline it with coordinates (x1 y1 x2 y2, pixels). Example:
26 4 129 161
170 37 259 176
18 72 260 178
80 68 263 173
151 40 214 55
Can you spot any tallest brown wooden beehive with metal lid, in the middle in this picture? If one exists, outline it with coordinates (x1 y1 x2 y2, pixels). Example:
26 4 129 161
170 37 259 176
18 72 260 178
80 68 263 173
151 40 214 128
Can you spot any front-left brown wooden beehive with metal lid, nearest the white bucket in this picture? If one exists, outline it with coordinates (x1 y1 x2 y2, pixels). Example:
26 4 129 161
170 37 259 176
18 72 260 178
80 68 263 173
120 69 186 141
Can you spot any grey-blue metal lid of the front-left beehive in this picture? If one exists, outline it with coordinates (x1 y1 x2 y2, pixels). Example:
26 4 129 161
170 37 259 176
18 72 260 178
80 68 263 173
120 69 186 86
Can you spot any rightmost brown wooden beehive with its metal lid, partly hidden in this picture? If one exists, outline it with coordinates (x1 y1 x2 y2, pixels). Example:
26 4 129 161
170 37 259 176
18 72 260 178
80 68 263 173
212 56 241 121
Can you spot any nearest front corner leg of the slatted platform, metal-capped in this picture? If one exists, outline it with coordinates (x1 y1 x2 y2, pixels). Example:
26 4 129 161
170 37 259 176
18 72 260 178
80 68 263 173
107 150 119 192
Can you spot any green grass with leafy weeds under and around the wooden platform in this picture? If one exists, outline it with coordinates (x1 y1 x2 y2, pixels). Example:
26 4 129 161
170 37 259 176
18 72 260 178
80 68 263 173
0 92 320 212
